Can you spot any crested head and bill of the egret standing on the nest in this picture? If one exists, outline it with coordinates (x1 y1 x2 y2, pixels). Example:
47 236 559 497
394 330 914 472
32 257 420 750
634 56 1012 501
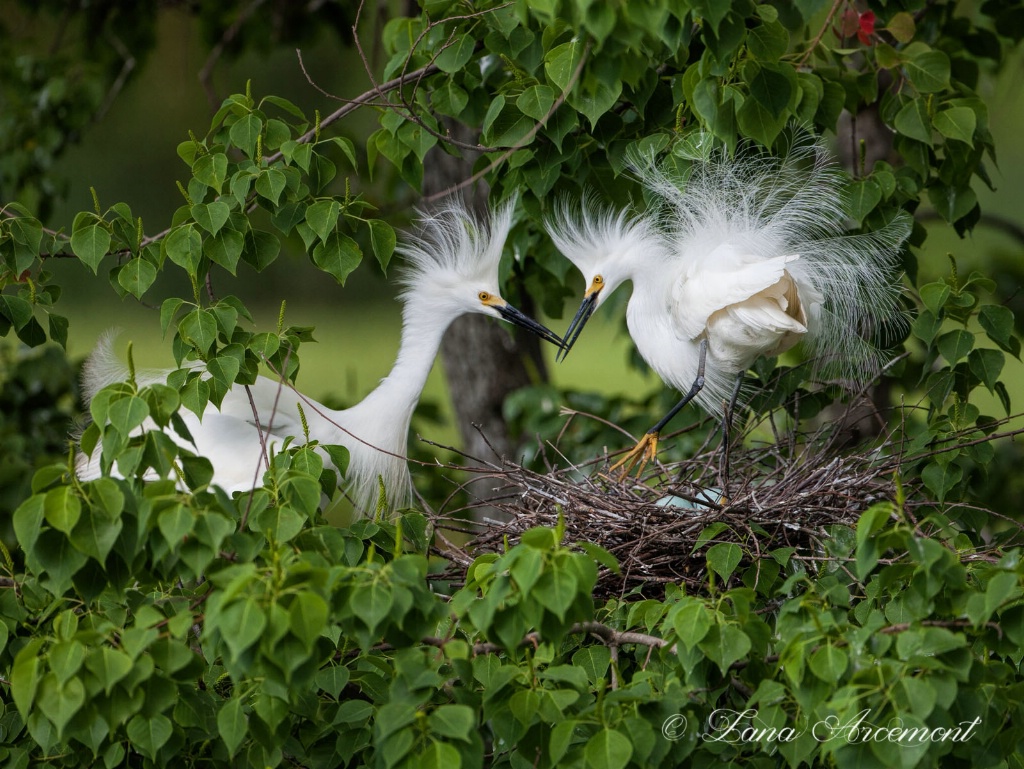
546 197 662 359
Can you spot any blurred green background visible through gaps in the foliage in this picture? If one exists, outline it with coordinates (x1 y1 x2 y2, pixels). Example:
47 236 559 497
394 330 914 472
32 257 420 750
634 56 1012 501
6 1 1024 442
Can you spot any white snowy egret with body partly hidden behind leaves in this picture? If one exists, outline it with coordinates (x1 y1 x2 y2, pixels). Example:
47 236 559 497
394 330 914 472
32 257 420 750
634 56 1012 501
78 195 561 513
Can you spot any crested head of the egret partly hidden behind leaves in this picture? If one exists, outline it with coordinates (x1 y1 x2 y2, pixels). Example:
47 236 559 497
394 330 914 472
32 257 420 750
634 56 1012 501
397 198 562 345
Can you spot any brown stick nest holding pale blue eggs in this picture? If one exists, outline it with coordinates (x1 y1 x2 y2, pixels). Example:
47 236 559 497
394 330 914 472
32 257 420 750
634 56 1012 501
425 409 1015 597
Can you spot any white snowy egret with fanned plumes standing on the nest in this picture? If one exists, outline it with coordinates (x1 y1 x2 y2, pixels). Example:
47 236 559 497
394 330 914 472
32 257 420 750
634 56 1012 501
547 135 910 475
